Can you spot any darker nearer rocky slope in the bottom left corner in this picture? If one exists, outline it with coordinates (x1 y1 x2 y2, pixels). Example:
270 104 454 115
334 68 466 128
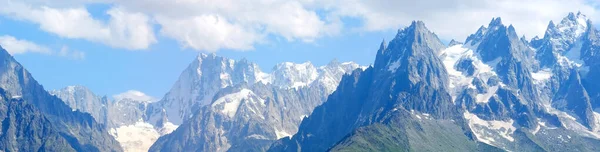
0 89 75 151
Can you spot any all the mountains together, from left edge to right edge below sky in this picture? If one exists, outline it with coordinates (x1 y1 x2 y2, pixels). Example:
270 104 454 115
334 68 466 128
0 13 600 152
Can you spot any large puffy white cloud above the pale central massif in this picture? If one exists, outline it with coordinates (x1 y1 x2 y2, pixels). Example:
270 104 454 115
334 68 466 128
124 0 340 52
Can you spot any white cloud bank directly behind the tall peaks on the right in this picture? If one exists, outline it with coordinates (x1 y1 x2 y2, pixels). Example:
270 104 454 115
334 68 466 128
312 0 600 40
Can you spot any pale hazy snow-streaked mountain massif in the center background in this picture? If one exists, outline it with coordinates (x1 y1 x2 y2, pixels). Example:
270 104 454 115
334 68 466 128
150 54 360 151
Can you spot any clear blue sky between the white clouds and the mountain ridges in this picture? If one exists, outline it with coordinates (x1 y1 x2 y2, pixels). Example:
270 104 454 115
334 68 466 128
0 5 395 98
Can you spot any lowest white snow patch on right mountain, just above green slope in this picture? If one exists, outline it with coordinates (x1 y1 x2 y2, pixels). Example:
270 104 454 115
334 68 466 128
463 112 516 147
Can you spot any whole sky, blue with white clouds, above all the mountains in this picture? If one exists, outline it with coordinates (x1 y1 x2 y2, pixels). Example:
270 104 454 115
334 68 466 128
0 0 598 98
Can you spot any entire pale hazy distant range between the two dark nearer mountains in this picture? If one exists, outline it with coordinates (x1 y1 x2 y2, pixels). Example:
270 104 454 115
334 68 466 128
50 54 365 151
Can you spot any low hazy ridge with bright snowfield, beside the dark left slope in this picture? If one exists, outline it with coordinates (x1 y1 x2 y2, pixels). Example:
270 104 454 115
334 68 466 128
51 86 162 152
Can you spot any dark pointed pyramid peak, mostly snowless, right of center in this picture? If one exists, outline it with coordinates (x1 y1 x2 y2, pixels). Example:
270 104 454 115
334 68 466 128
270 21 462 151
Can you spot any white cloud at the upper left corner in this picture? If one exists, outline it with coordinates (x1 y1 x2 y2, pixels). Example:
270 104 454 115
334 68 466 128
0 0 156 50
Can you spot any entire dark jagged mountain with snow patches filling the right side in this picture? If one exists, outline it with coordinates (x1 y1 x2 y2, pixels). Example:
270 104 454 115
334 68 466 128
269 13 600 151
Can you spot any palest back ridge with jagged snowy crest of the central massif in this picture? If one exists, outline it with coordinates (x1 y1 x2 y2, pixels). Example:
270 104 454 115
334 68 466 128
147 54 359 126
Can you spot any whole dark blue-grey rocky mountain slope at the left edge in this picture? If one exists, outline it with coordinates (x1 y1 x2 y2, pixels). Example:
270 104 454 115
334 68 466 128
0 45 122 151
